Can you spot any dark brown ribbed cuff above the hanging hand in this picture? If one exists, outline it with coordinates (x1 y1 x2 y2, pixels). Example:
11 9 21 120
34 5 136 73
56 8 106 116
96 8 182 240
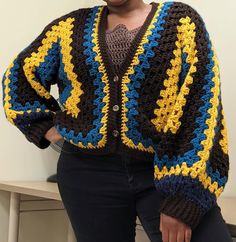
159 195 205 230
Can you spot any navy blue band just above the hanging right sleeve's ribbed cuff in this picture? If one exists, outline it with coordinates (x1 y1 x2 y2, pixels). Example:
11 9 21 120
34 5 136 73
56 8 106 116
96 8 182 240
154 174 216 211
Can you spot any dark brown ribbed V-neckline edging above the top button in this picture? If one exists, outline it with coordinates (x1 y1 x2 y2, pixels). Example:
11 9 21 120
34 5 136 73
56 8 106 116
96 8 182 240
98 2 158 78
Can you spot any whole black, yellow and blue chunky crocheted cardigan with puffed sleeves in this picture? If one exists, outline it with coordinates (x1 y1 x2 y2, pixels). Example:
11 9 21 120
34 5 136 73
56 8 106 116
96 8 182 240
2 2 229 228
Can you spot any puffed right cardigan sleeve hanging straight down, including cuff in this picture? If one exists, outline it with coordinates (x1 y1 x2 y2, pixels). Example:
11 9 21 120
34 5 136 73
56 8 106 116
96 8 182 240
154 5 229 229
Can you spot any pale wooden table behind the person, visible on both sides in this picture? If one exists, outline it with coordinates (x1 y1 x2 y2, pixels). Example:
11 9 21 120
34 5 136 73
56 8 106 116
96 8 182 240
0 181 236 242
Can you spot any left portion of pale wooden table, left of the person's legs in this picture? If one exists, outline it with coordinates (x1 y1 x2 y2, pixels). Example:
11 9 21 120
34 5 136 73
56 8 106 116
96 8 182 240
0 181 76 242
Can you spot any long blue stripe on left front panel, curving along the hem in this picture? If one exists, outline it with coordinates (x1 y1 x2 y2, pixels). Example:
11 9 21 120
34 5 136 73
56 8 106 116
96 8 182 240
58 6 105 146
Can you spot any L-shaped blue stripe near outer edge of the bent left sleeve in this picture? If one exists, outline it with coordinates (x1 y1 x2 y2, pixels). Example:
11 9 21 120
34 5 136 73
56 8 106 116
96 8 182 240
6 58 48 112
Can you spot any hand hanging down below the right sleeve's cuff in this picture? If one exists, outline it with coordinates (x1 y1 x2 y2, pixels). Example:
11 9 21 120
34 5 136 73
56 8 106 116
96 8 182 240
160 213 192 242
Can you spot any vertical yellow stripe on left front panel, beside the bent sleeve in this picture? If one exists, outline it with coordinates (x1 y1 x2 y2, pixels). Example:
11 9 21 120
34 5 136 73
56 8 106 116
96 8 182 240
60 18 84 118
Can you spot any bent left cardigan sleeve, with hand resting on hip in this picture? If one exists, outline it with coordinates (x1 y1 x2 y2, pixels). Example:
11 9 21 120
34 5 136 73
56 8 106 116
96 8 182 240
2 19 60 149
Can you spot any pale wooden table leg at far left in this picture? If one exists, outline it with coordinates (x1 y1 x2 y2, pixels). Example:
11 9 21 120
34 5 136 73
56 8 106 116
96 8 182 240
8 192 20 242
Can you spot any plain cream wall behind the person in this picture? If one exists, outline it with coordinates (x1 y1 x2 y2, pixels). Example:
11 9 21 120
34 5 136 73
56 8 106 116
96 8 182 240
0 0 236 242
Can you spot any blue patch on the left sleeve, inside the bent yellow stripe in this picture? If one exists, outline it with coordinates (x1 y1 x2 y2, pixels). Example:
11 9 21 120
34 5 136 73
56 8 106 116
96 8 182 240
35 42 60 90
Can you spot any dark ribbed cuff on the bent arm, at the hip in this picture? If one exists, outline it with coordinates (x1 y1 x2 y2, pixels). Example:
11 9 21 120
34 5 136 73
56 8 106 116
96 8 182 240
25 119 54 149
